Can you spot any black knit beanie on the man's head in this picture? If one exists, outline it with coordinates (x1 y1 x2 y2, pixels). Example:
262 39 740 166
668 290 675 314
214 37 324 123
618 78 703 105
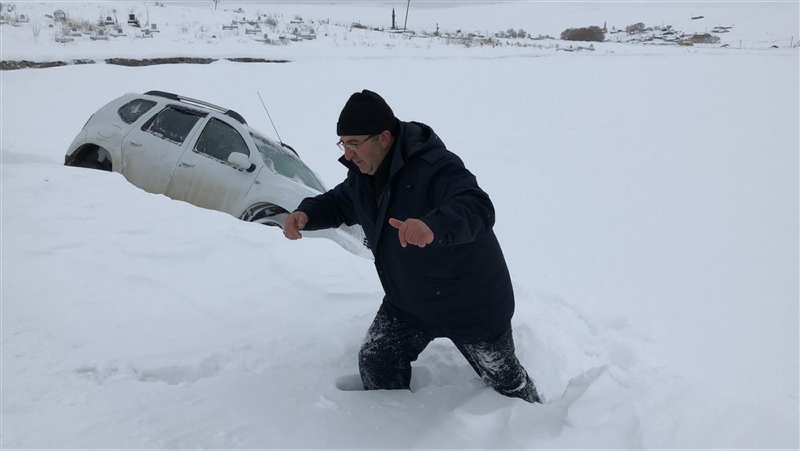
336 89 397 136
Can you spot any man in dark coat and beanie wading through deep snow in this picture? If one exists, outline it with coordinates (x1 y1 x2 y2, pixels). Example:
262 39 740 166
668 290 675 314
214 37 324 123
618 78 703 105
284 90 541 402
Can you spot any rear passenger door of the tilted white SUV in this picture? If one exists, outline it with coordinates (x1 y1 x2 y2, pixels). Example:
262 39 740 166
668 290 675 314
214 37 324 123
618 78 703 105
122 105 207 194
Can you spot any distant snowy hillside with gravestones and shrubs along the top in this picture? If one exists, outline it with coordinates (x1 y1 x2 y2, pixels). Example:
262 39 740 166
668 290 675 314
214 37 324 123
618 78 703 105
0 1 800 61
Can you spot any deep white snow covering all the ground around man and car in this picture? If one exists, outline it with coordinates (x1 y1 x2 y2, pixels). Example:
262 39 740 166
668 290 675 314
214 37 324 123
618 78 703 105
0 2 800 448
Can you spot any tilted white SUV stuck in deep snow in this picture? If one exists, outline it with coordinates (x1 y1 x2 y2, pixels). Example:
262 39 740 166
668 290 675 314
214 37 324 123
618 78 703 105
64 91 372 258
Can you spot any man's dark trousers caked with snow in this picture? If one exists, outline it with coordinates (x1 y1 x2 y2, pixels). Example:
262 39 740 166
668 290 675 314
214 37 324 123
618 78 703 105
358 304 541 402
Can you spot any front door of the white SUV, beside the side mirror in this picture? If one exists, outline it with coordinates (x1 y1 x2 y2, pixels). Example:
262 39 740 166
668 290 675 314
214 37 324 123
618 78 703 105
167 116 263 216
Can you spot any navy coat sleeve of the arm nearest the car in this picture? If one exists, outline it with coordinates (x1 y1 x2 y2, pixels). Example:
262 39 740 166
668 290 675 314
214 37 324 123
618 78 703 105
296 180 358 230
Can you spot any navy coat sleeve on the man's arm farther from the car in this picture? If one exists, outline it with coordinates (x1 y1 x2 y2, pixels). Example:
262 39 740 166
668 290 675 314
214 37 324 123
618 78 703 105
420 156 495 246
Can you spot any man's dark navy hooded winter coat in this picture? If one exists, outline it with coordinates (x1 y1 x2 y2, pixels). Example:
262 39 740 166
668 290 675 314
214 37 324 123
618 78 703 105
298 122 514 342
